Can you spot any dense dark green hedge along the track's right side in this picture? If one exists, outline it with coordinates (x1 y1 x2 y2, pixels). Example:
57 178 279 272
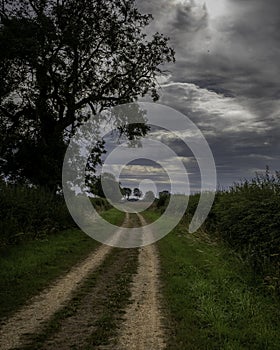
188 169 280 292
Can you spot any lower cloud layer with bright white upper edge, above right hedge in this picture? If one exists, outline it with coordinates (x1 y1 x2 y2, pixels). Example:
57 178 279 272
159 84 280 185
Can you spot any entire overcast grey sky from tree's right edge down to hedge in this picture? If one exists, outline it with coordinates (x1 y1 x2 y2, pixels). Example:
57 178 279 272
103 0 280 194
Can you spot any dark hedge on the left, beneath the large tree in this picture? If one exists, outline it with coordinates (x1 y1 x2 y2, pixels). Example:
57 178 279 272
0 182 74 245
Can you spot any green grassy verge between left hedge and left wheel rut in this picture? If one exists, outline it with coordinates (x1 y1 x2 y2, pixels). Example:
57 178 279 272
0 209 124 318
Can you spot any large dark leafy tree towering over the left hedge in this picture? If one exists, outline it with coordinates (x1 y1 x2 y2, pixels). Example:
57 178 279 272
0 0 174 189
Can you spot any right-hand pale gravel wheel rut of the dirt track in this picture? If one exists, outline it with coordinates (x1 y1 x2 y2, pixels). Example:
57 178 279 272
109 214 165 350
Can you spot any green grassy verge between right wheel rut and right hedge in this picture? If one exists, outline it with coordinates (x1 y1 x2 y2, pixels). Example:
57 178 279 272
145 212 280 350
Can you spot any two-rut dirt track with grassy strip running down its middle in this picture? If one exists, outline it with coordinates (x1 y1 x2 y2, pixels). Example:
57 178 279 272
0 215 165 350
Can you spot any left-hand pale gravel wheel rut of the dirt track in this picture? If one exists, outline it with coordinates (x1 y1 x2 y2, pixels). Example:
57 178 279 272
0 215 128 350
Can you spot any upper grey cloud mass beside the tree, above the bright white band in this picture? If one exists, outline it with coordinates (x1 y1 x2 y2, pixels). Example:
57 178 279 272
139 0 280 99
